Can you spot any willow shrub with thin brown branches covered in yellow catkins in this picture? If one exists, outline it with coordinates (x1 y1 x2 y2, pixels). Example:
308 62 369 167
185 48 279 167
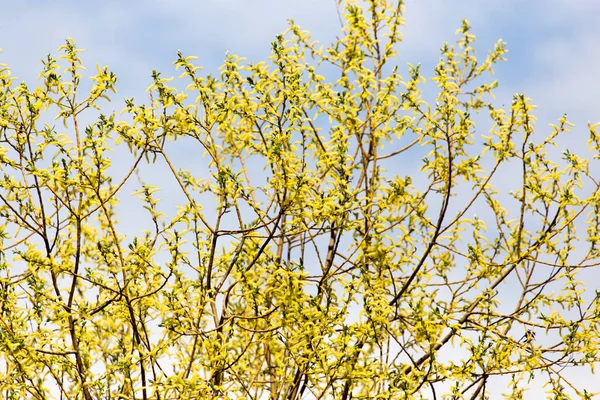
0 0 600 400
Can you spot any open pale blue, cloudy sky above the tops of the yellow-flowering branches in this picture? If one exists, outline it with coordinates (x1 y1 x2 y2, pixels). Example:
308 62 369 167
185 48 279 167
0 0 600 398
